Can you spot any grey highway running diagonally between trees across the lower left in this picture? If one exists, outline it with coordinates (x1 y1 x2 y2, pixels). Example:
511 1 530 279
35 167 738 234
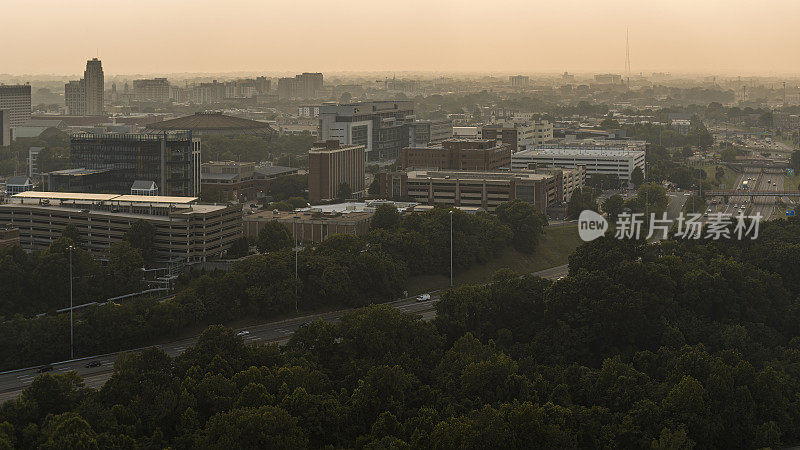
0 265 568 403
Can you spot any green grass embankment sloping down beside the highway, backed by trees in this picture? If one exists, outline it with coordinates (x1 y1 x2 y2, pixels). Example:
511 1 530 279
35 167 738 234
408 225 581 295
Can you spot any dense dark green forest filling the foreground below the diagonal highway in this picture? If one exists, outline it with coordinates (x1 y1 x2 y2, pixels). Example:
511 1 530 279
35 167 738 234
0 217 800 449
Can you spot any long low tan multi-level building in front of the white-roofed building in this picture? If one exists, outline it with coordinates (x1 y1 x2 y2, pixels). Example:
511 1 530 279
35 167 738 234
378 170 563 213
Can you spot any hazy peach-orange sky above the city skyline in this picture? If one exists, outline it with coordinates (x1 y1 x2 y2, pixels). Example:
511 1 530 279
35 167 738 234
0 0 800 75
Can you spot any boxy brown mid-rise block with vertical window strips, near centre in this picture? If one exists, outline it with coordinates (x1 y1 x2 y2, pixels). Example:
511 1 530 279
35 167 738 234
308 139 366 203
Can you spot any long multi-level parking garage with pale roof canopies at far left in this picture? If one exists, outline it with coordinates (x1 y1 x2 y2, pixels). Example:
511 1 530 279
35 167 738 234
0 191 242 262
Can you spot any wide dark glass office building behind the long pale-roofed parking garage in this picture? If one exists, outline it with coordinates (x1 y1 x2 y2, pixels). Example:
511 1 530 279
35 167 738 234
58 131 201 196
